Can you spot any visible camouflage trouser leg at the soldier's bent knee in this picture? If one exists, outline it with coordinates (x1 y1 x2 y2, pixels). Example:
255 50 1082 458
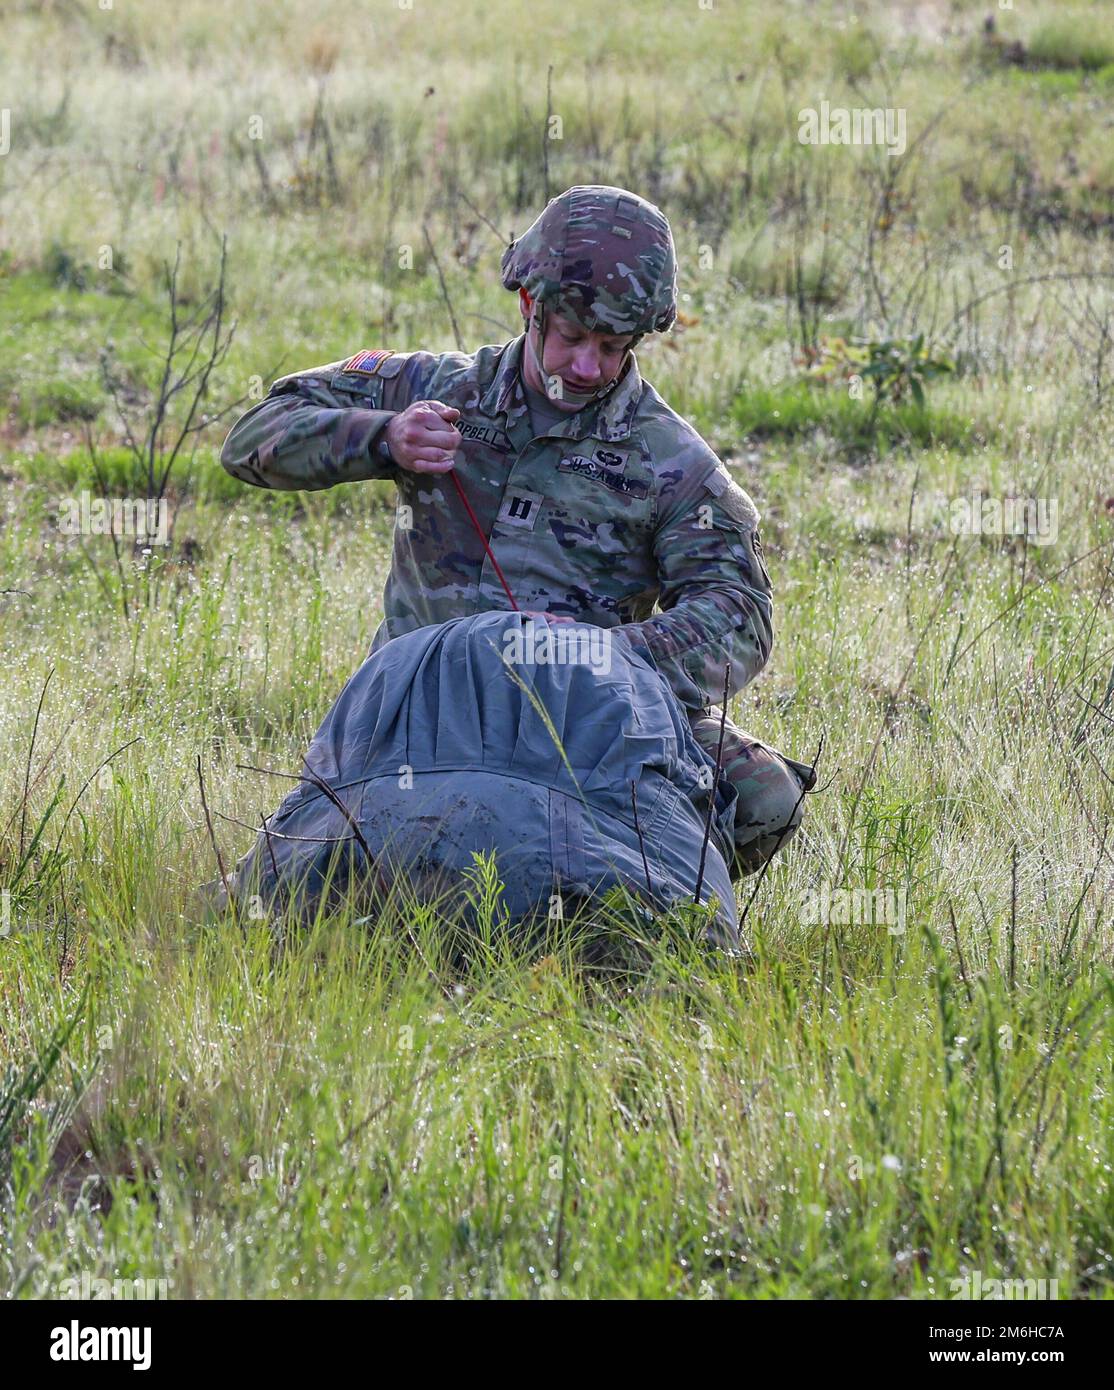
693 709 816 878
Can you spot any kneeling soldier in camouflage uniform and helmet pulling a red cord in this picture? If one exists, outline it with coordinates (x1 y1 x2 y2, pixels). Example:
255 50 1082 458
221 185 814 873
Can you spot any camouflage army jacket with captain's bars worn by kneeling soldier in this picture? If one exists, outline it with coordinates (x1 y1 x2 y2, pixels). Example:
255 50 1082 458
221 336 773 710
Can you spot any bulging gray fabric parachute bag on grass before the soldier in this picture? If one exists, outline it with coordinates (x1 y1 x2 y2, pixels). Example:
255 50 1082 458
234 612 738 948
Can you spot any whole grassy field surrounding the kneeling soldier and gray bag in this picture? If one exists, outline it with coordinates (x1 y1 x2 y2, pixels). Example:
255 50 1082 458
0 0 1114 1298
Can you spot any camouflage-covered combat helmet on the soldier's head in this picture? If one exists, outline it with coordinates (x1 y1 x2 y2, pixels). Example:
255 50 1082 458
502 183 677 338
